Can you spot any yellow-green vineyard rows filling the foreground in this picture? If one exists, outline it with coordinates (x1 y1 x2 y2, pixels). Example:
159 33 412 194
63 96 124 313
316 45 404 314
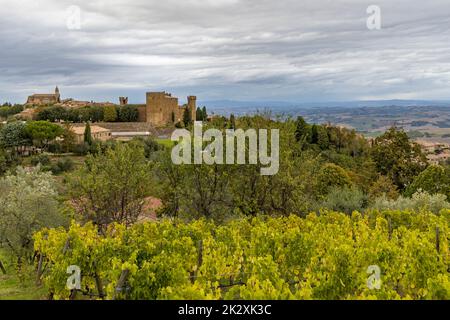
34 210 450 299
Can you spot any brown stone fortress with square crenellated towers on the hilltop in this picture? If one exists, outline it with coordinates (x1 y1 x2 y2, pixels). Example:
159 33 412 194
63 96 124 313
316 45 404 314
139 92 197 126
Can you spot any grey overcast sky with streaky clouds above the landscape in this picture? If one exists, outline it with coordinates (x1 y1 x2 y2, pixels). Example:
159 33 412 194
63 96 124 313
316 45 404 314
0 0 450 103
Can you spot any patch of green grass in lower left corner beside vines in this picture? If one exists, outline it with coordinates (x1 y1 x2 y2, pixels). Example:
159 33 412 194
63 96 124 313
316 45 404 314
0 249 47 300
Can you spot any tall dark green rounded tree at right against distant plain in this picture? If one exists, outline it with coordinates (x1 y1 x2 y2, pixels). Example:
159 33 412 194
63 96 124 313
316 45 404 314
371 127 428 190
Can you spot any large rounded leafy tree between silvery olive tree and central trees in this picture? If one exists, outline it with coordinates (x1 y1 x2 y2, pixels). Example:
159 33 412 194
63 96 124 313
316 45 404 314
69 143 150 231
